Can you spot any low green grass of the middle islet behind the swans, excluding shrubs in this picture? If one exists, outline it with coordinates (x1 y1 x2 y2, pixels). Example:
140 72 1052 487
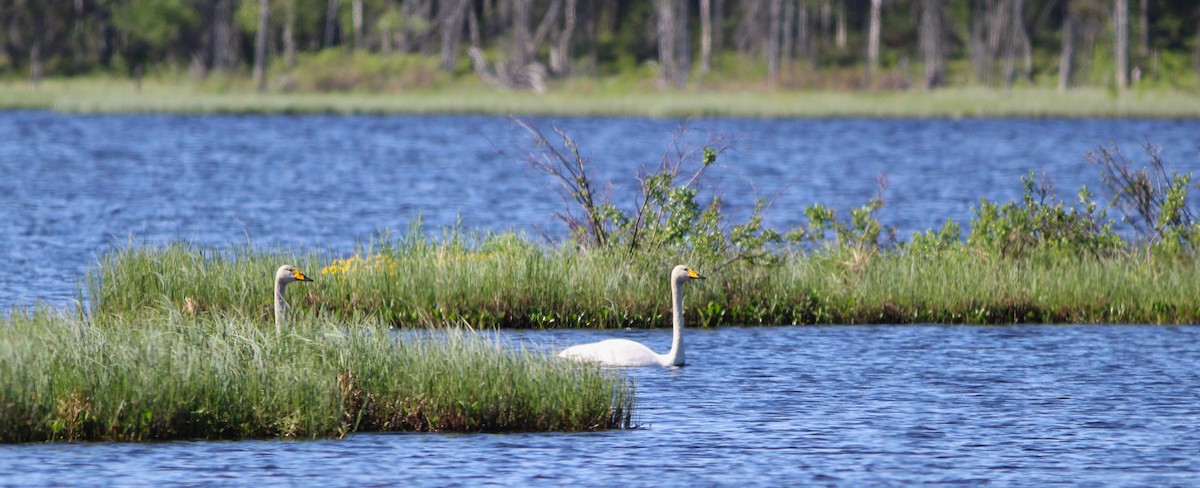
88 234 1200 329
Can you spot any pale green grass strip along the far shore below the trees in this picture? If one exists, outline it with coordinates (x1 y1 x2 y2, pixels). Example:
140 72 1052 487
7 78 1200 118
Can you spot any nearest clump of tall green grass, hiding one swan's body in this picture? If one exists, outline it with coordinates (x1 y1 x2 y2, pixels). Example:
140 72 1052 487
0 311 634 442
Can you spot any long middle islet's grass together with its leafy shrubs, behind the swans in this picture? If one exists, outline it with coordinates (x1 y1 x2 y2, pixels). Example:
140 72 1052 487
84 131 1200 329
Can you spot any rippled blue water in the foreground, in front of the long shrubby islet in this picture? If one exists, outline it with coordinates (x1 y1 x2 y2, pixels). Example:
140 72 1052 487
0 326 1200 486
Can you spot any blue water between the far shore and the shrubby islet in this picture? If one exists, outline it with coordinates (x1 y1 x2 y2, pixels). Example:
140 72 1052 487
0 112 1200 311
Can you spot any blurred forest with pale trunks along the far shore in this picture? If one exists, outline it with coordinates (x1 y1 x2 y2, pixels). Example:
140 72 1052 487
0 0 1200 90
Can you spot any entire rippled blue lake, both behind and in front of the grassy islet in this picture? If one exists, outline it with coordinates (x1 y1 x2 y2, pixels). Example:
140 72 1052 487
0 112 1200 486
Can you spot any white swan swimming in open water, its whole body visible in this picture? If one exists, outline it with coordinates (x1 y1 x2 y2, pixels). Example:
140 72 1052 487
558 265 704 367
